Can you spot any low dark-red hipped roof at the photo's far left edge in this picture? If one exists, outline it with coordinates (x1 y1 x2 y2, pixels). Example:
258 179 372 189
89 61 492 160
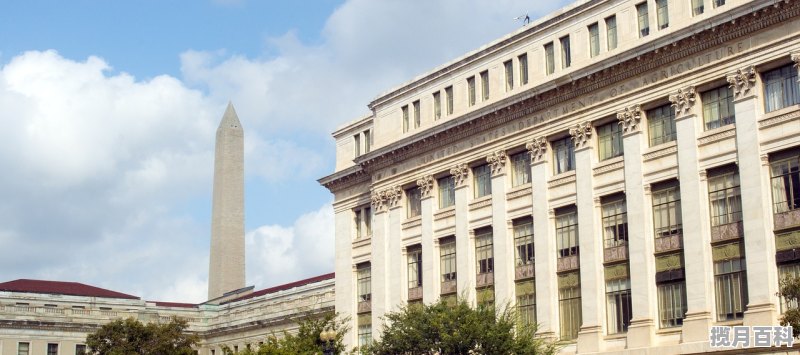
0 279 139 300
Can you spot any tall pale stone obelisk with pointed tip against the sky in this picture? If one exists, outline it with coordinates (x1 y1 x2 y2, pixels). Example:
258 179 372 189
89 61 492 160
208 102 245 299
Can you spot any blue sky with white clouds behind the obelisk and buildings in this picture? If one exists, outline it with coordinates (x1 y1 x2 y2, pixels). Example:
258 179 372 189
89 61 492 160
0 0 567 302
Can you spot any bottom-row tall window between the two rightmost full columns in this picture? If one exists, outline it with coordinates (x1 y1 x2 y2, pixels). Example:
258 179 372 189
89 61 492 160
714 258 747 321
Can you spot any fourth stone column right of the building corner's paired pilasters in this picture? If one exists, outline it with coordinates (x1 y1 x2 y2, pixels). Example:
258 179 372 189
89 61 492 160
526 137 560 338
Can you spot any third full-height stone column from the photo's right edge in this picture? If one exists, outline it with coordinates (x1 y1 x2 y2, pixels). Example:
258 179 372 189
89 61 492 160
617 105 658 349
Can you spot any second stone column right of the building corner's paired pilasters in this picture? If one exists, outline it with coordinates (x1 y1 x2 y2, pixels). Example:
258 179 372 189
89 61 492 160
450 164 475 305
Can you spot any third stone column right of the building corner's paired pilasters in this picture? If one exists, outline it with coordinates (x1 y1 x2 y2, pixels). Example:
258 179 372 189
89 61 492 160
486 150 515 308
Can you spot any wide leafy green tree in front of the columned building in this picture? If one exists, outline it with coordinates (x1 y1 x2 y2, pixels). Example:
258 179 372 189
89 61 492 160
361 299 558 355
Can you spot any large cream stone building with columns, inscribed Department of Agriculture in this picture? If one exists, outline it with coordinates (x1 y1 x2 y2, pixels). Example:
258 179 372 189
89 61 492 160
320 0 800 353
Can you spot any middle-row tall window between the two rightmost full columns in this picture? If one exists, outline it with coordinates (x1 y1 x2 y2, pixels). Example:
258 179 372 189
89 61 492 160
708 171 742 226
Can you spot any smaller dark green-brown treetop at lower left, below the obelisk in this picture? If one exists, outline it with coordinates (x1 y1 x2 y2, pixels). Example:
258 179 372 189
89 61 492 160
86 318 199 355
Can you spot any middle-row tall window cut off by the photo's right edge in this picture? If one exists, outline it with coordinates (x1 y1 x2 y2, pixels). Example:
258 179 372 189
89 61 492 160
770 151 800 213
